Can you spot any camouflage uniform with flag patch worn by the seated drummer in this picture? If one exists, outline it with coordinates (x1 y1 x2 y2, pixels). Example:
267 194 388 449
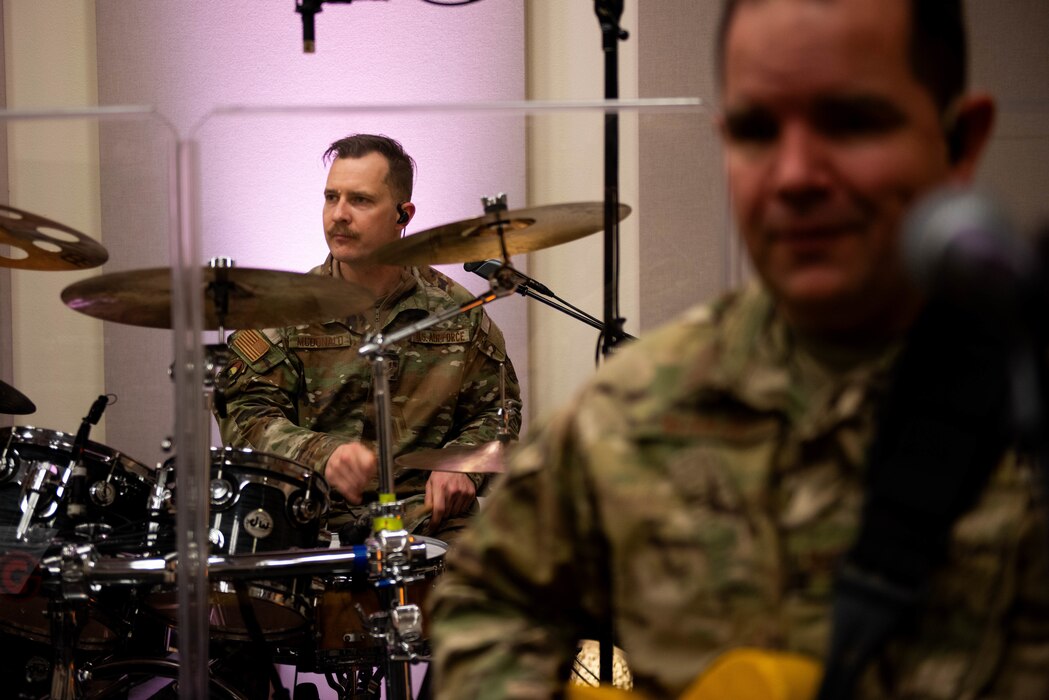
219 255 520 530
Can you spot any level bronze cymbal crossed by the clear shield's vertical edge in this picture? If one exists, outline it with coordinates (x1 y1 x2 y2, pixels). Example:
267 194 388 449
62 268 374 330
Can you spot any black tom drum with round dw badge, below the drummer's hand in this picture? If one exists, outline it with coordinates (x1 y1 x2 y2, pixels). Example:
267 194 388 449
149 448 328 640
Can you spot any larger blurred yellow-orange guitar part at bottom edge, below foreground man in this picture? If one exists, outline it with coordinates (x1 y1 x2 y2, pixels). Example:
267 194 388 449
681 648 823 700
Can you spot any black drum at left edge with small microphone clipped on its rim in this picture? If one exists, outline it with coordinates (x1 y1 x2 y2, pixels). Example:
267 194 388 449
0 426 154 551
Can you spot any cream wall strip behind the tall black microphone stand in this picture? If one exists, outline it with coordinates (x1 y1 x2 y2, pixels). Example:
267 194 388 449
528 0 642 418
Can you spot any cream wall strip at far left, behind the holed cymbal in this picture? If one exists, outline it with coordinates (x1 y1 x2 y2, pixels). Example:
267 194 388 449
3 0 106 440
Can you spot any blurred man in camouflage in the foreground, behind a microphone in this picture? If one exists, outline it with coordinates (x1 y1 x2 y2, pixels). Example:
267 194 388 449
432 0 1049 700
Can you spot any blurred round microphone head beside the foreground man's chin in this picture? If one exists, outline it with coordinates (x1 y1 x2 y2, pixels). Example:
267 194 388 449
902 188 1037 309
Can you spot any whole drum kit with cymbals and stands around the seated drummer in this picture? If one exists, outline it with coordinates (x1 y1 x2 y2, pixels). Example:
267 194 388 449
0 197 629 700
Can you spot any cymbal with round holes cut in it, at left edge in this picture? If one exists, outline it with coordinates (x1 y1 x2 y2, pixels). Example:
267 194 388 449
0 205 109 270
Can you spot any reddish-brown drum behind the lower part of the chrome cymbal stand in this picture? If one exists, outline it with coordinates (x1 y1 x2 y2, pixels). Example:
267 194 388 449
315 535 448 673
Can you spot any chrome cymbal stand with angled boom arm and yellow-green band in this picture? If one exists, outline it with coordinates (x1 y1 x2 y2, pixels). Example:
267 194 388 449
358 264 517 700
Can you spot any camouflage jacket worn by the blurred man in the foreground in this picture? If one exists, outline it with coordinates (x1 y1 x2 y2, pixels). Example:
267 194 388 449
431 289 1049 700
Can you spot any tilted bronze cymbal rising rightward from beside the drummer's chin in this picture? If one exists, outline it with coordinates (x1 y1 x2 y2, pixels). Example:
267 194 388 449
372 201 630 264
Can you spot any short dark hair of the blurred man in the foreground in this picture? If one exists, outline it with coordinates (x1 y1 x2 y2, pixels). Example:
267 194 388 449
716 0 968 114
